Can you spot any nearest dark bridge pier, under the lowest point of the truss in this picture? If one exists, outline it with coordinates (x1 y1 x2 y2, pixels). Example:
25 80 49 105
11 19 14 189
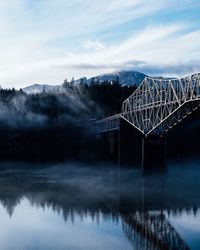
142 136 166 172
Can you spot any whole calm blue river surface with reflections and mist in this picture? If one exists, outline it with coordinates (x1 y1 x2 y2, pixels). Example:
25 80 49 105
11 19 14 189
0 161 200 250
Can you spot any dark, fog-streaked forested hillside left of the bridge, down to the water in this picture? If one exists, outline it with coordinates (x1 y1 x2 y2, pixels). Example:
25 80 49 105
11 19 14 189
0 82 134 161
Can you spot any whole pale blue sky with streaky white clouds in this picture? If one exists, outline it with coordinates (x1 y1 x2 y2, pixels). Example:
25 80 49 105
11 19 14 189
0 0 200 88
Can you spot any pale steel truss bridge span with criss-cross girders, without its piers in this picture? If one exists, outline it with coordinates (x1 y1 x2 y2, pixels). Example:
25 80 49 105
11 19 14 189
95 73 200 137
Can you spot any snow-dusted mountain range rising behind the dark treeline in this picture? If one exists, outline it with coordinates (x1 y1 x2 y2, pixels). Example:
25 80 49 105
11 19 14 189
23 70 147 94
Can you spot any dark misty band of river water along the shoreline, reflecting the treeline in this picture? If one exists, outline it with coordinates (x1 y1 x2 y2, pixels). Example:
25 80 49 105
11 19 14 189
0 162 200 216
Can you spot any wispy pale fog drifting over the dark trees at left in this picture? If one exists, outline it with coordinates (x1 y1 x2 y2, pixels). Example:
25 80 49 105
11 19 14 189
0 87 102 128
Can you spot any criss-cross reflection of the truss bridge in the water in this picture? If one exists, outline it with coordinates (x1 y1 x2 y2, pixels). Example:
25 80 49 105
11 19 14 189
122 212 189 250
